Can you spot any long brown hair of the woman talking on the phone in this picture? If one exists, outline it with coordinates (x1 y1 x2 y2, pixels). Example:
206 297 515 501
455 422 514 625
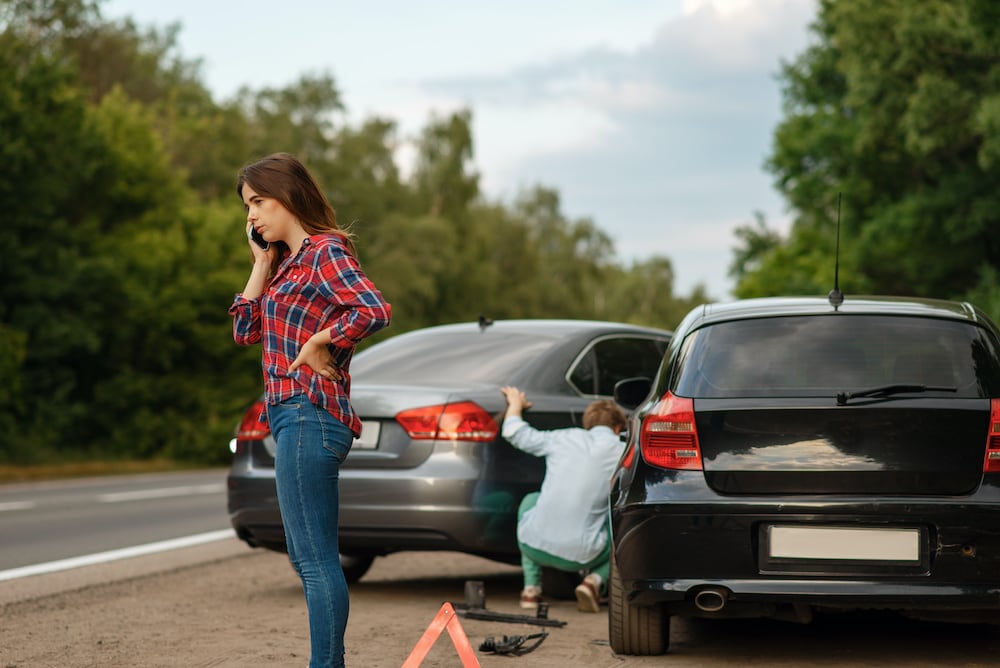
236 153 357 275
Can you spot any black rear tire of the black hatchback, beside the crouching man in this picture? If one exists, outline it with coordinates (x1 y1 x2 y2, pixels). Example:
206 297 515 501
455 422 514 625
608 550 670 656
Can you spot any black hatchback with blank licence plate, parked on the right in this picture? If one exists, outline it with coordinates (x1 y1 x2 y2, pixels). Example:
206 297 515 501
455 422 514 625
609 297 1000 654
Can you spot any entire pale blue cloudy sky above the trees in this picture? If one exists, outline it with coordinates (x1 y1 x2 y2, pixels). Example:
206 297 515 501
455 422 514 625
101 0 816 300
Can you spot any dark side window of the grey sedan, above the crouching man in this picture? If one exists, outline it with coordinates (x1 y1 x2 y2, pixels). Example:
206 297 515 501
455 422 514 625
569 336 668 397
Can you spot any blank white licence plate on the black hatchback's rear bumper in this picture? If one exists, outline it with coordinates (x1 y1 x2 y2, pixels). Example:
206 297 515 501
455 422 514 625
768 526 920 564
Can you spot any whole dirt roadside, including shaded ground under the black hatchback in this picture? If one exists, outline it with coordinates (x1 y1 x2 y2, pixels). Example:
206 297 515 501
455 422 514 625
0 534 1000 668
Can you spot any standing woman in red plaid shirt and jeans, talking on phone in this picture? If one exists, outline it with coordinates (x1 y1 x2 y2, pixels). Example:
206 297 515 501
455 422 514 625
229 153 391 668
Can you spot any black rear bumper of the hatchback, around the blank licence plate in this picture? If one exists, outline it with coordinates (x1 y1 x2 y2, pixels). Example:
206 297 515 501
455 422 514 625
612 490 1000 612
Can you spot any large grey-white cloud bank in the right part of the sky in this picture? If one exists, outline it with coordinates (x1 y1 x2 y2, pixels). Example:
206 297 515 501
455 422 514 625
402 0 813 297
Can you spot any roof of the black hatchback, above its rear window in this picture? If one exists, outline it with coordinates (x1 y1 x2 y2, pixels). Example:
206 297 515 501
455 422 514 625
679 295 989 330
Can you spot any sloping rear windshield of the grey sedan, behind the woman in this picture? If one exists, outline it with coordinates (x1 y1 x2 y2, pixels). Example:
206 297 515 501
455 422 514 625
351 329 557 385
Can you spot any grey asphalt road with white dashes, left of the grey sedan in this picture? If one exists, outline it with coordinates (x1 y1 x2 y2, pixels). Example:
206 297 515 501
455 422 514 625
0 469 230 571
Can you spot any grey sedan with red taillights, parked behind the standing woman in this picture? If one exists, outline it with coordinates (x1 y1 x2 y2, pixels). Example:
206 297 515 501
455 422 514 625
228 320 670 584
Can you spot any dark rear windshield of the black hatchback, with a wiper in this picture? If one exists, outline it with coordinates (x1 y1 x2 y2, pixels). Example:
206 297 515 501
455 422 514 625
674 314 1000 398
